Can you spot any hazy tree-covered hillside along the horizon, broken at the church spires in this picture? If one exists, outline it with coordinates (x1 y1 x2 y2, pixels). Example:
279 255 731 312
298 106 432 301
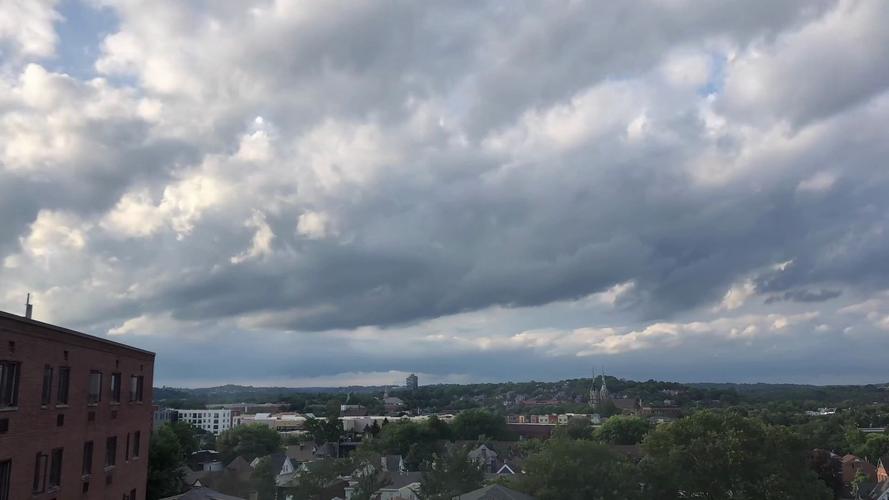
154 377 889 411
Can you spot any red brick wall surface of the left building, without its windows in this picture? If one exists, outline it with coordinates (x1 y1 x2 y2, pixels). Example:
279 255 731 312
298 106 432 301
0 313 154 500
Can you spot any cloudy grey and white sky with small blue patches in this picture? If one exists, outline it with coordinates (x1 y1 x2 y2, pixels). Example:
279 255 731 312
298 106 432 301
0 0 889 387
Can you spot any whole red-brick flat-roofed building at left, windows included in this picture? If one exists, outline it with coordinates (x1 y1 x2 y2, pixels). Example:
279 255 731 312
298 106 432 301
0 312 154 500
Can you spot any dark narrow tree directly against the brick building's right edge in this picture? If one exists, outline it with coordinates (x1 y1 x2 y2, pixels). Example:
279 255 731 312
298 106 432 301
147 424 185 500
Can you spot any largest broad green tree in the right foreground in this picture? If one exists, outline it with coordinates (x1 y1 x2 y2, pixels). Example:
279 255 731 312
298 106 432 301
642 411 833 500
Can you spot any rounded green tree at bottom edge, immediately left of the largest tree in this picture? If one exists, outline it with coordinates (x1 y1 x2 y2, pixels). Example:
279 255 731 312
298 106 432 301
517 438 641 500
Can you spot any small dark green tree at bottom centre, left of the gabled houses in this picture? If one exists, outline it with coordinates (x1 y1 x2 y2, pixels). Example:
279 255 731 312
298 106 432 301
417 447 485 500
